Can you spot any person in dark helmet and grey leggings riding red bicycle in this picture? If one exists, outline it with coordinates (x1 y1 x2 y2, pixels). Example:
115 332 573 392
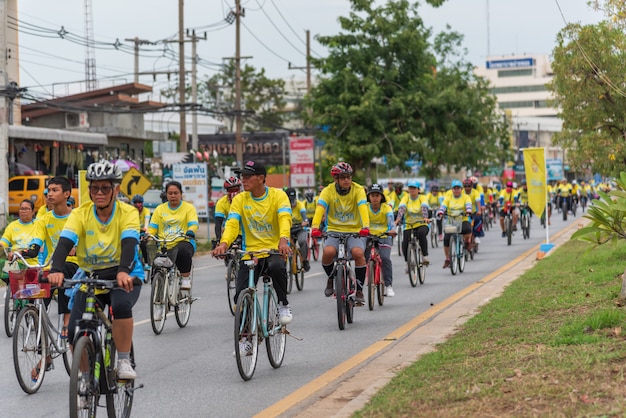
365 183 396 297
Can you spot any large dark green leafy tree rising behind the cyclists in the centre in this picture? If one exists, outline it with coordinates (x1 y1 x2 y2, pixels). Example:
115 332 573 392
308 0 509 178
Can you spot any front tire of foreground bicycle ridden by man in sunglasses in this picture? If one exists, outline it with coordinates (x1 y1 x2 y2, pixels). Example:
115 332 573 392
69 335 100 418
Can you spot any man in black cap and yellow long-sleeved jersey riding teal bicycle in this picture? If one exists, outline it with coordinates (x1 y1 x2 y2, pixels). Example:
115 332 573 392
212 161 293 325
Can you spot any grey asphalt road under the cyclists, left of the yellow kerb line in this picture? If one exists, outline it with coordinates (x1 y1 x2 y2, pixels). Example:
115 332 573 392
0 214 578 417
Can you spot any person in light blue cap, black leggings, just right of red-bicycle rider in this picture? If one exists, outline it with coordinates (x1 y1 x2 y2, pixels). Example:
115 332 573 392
395 179 430 264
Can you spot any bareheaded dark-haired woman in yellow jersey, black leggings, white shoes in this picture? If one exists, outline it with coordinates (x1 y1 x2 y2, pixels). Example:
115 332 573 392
148 181 198 290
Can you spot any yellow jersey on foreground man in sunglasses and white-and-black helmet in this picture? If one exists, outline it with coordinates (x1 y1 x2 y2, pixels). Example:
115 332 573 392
60 201 144 278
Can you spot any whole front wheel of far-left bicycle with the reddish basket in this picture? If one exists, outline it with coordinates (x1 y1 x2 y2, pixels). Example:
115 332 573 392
13 305 47 393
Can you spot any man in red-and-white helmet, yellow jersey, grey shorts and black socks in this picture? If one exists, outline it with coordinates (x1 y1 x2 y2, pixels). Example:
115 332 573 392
311 161 370 304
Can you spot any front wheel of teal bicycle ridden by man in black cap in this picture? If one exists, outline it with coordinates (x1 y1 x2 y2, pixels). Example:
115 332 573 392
235 289 259 380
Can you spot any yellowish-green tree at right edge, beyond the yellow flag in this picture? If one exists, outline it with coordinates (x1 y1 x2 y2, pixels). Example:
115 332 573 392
550 17 626 175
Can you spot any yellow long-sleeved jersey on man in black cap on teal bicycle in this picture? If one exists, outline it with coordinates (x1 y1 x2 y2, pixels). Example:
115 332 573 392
221 187 292 251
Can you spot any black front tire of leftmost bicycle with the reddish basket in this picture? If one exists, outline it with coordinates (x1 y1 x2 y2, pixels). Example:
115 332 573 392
12 305 48 394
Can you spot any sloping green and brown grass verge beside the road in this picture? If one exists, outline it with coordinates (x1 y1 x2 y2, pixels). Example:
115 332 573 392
355 241 626 417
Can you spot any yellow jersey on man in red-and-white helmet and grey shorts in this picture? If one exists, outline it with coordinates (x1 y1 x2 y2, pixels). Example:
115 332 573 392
312 182 370 233
